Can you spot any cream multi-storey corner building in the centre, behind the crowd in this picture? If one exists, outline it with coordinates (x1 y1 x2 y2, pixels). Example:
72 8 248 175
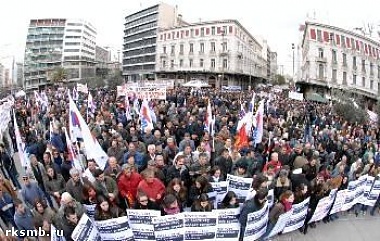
155 20 267 87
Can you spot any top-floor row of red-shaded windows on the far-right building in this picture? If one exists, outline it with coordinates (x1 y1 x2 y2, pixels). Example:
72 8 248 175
310 28 380 59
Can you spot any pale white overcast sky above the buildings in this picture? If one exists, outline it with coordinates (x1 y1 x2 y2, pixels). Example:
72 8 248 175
0 0 380 73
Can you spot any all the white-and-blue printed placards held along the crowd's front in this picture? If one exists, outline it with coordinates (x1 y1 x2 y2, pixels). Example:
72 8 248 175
52 175 380 241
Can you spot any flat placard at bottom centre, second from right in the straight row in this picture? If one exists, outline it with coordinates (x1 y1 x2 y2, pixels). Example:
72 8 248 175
183 212 218 241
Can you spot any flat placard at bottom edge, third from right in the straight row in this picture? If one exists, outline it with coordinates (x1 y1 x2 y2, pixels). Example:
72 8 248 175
153 214 184 241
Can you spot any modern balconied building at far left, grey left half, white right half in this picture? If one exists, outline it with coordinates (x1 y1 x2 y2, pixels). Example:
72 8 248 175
24 19 97 89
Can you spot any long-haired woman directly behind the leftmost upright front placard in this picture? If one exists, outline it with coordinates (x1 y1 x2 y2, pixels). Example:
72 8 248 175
94 196 125 220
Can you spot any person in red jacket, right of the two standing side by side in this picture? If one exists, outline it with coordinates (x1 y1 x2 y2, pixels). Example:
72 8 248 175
137 169 165 203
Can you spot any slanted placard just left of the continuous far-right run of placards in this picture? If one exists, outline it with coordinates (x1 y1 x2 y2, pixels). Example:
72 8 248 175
282 198 310 233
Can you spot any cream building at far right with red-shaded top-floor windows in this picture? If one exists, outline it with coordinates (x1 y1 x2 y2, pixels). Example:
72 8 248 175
300 22 380 99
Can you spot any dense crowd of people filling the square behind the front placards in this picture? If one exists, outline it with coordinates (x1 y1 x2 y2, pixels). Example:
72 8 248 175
0 85 380 241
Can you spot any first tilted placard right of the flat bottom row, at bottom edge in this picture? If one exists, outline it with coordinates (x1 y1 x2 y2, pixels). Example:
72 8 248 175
240 202 269 241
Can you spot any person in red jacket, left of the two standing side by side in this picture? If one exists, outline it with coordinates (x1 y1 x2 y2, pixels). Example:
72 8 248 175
117 164 142 207
